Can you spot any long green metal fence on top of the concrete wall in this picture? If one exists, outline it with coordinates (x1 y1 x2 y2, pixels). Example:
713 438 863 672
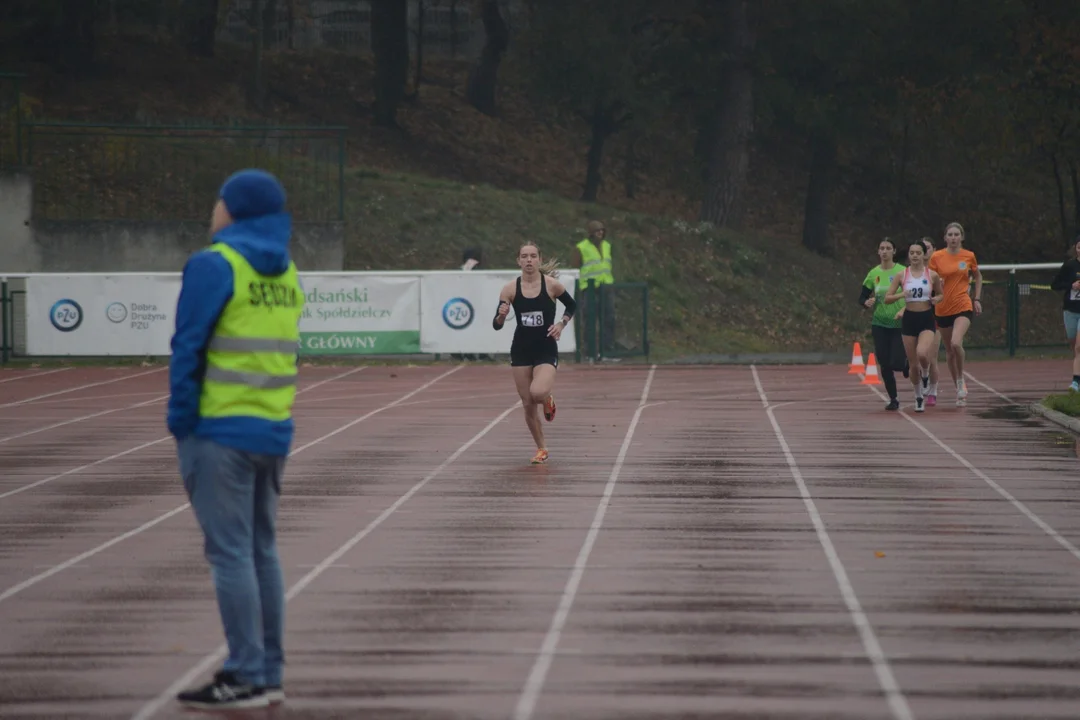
23 122 347 222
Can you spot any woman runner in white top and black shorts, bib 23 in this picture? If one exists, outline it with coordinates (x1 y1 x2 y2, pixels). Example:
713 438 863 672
885 243 942 412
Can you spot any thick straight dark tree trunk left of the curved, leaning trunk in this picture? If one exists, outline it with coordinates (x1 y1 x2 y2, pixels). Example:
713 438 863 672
372 0 408 127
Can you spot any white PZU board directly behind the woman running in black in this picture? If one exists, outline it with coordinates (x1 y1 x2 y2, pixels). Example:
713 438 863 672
420 270 578 355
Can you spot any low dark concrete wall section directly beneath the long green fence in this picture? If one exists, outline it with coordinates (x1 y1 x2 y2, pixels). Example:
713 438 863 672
32 220 345 272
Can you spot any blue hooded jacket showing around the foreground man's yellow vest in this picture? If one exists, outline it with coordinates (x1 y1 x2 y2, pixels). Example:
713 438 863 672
166 213 294 456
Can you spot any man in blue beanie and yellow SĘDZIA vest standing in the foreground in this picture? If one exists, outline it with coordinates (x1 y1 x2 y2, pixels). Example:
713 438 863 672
166 169 303 709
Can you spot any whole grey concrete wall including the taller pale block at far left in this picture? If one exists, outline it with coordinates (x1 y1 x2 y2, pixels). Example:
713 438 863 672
0 171 345 274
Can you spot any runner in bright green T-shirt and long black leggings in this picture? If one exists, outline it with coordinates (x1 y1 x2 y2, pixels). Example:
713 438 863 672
859 237 905 410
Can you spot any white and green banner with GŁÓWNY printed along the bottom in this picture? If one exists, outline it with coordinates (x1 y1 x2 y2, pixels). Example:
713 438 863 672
300 273 420 355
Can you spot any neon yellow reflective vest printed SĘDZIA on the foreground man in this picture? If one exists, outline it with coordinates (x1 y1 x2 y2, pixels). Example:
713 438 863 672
199 243 303 421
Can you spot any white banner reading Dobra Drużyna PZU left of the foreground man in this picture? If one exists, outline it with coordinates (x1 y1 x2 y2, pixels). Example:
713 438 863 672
26 274 180 356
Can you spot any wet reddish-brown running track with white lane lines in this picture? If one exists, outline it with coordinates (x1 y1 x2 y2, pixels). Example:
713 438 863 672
0 362 1080 720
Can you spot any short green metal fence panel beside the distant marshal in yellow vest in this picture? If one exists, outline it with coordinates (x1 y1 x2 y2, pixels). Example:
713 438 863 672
575 281 649 362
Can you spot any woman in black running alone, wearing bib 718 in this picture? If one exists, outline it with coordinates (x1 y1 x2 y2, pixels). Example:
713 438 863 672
491 243 577 464
